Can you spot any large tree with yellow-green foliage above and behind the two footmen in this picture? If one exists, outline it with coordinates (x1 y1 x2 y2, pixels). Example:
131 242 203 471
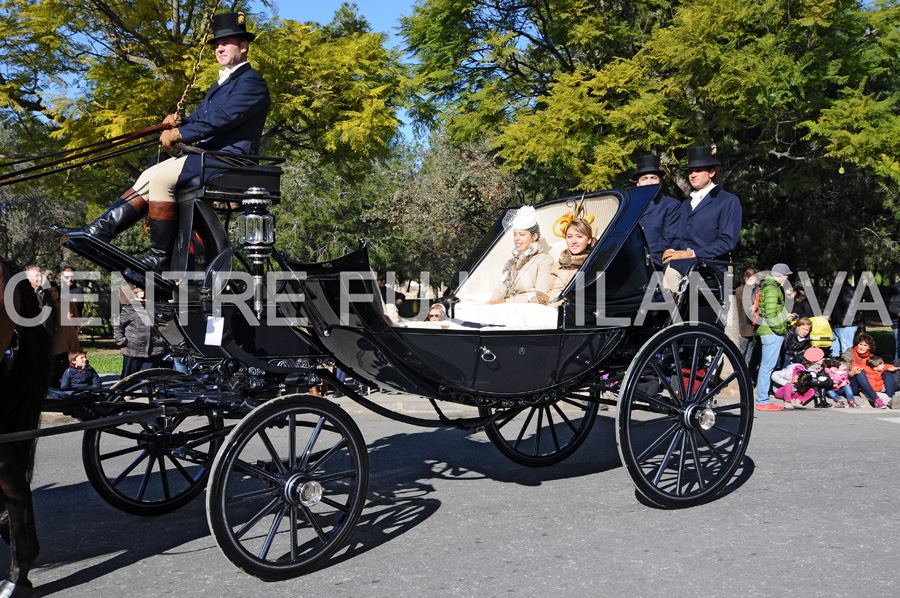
404 0 900 267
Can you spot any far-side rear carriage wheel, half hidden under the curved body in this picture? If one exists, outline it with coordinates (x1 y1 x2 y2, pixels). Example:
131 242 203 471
478 393 600 467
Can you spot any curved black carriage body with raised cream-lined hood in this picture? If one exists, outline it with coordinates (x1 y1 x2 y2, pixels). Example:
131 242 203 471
288 187 659 406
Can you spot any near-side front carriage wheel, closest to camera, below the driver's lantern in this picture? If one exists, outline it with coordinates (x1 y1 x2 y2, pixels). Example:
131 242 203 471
206 395 369 581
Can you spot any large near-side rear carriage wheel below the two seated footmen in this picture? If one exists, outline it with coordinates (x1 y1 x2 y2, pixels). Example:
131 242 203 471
617 323 753 508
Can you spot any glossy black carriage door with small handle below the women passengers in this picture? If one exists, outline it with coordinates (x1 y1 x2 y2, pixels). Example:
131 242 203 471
473 330 560 394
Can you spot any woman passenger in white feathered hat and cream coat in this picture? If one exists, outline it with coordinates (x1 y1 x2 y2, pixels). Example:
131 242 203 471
488 206 553 305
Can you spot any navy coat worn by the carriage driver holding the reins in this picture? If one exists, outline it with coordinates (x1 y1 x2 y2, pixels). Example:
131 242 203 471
168 65 271 187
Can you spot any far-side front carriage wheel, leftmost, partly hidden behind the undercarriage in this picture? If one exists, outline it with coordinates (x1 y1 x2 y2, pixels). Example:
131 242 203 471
81 368 223 516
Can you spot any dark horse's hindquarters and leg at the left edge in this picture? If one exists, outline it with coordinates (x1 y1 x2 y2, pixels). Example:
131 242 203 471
0 259 52 598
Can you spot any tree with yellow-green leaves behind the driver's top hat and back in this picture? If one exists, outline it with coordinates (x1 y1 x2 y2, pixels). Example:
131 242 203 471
0 0 408 205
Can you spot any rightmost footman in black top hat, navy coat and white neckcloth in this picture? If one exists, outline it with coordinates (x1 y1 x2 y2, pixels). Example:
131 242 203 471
662 146 743 290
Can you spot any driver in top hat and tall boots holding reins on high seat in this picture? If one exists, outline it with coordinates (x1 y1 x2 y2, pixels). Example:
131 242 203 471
53 12 271 272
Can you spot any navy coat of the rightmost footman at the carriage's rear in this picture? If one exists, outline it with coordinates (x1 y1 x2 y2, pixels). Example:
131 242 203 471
669 185 743 273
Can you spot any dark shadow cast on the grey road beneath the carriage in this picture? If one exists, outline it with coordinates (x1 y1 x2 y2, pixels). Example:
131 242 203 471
0 415 754 596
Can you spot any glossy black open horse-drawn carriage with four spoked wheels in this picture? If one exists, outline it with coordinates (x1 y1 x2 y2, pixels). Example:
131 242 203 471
5 156 753 579
